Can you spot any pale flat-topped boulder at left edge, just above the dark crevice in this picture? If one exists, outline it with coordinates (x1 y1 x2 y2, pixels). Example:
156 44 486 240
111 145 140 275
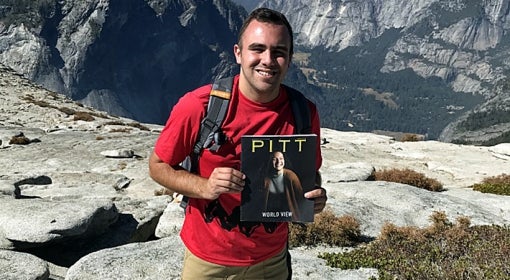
0 198 119 249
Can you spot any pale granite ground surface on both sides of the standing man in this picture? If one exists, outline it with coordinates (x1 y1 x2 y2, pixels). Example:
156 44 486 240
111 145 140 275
0 64 510 279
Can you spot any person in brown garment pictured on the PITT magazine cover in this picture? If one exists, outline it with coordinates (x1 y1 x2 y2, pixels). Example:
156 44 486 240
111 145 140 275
264 151 305 221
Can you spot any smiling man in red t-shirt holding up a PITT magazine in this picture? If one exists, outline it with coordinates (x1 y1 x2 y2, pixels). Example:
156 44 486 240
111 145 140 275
149 8 327 279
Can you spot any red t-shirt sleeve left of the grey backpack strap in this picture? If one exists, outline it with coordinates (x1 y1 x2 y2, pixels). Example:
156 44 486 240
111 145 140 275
154 86 210 165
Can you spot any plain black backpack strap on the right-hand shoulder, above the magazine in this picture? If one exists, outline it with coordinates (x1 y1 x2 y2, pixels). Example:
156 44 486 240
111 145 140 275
285 86 312 134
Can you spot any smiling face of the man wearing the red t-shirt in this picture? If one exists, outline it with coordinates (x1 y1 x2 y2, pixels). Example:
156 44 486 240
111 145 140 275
234 20 291 103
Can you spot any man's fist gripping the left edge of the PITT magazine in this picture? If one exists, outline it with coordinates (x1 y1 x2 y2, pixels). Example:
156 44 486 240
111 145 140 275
199 167 246 200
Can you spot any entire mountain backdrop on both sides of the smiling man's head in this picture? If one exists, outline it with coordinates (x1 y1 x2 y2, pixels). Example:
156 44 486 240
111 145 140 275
0 0 510 145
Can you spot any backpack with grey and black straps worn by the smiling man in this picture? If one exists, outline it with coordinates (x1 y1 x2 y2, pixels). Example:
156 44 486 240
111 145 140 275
180 77 312 209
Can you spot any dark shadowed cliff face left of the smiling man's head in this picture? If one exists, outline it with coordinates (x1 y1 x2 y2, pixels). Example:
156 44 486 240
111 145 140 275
0 0 245 123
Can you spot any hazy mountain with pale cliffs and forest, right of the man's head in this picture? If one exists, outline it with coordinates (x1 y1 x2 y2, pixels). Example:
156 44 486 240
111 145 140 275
259 0 510 144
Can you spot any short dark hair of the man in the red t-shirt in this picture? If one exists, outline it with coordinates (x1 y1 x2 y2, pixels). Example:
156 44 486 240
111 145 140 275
237 8 294 55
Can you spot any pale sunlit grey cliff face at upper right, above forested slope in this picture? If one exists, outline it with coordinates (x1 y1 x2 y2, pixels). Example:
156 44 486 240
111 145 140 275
260 0 510 142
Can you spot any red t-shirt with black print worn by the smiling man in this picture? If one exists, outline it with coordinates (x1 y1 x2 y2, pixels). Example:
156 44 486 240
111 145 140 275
155 76 322 266
